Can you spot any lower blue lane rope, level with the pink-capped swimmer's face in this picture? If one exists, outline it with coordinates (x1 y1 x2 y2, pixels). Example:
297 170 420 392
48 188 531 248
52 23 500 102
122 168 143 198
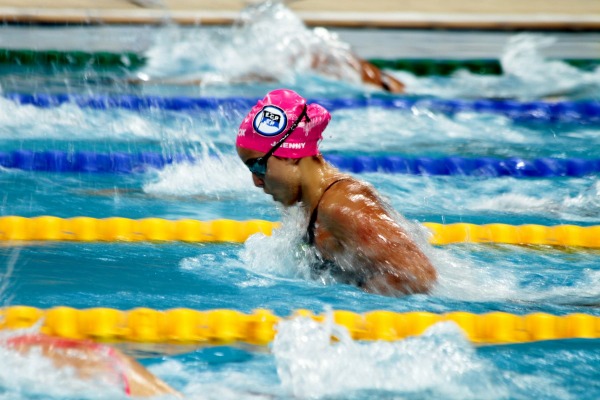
0 150 600 178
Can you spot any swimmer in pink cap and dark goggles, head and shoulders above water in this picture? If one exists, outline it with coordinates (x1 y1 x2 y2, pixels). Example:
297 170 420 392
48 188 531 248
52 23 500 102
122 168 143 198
236 89 437 296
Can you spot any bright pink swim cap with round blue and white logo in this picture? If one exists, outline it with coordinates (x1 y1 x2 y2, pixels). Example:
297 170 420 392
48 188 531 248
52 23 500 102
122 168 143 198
235 89 331 158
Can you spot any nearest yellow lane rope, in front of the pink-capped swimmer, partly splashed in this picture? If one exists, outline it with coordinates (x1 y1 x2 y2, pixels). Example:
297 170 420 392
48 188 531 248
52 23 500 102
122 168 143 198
0 306 600 345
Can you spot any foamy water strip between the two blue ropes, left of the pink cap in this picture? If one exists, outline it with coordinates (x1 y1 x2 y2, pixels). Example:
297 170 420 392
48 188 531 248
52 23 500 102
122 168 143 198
0 98 241 152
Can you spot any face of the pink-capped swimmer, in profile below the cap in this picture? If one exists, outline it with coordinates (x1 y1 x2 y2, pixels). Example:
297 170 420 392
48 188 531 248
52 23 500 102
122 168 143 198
237 147 300 206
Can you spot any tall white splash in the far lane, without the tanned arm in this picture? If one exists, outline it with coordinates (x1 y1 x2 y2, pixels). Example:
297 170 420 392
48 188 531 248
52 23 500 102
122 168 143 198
142 2 360 89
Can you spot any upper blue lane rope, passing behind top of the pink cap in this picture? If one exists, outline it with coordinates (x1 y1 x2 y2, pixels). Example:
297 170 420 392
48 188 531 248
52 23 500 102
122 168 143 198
4 93 600 124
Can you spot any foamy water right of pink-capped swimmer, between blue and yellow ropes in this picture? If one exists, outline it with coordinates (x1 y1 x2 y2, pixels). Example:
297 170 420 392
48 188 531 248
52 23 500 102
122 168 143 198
370 173 600 224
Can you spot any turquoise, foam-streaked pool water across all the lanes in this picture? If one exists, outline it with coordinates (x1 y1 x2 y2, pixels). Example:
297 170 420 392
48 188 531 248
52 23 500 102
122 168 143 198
0 3 600 399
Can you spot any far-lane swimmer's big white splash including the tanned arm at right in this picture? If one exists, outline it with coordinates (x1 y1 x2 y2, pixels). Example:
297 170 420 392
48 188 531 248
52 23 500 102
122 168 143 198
128 2 404 93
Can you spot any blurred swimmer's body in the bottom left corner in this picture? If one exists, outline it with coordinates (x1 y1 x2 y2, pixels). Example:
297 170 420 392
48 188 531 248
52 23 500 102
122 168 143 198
3 334 181 397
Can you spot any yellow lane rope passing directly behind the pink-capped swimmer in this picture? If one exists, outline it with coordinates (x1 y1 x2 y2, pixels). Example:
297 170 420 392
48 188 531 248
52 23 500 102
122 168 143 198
0 216 600 248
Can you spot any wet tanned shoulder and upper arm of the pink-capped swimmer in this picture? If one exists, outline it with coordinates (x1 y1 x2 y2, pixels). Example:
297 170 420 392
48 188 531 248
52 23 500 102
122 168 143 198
319 187 437 296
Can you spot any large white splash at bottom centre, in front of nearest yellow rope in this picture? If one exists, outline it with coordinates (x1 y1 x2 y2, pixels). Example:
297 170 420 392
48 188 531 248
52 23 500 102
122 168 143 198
143 315 507 399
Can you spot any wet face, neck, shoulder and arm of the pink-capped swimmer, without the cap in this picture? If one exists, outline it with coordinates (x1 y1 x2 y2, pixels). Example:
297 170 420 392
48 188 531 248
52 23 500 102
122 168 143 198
237 147 437 296
